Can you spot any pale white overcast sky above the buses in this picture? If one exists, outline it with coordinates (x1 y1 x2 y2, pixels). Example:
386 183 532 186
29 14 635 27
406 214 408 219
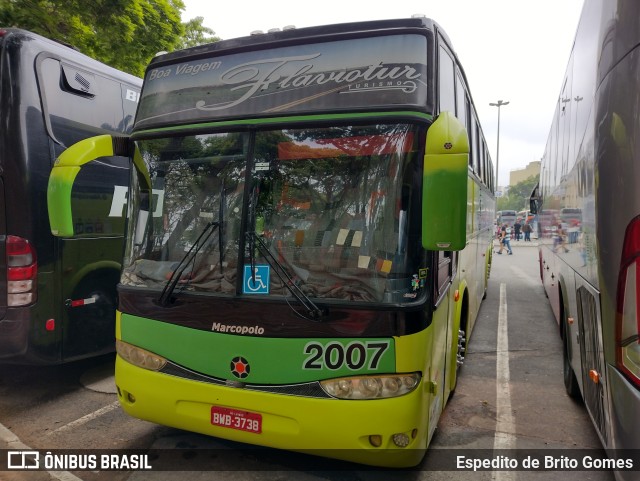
182 0 583 186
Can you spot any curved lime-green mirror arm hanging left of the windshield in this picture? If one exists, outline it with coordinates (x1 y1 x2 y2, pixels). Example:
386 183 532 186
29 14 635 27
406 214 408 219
47 135 148 237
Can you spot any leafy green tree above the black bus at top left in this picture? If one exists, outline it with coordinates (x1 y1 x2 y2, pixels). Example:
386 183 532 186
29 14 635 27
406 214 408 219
0 0 217 76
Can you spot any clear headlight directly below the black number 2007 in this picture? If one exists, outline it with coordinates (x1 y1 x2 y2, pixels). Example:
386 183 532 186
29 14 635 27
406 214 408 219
320 372 420 399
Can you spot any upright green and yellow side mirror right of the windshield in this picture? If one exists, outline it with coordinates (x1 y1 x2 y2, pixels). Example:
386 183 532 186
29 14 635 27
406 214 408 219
422 112 469 251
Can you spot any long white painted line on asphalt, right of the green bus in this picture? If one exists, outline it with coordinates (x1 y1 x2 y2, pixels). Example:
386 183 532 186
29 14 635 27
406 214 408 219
491 283 516 481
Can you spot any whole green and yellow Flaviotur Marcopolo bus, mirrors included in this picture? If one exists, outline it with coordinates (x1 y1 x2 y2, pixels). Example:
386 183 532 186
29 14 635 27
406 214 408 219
48 18 495 466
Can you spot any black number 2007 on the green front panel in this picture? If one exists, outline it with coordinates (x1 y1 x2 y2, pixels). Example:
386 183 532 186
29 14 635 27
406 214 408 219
303 341 389 371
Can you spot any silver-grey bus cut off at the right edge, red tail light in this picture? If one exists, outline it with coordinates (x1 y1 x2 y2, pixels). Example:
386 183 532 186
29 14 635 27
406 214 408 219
531 0 640 479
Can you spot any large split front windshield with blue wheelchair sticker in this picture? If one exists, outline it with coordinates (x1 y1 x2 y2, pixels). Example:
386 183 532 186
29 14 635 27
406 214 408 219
122 124 426 303
